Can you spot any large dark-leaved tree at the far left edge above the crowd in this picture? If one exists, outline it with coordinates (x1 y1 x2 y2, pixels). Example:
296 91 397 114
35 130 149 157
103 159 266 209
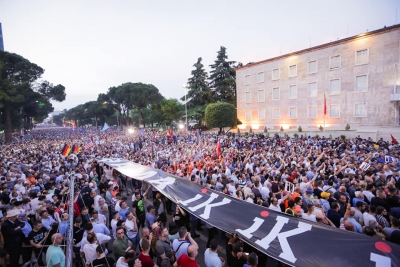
0 51 66 144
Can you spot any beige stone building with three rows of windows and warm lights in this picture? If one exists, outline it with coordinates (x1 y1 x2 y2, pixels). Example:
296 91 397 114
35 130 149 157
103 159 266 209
236 25 400 131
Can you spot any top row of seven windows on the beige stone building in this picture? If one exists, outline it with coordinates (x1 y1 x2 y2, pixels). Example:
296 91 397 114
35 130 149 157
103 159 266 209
244 49 369 85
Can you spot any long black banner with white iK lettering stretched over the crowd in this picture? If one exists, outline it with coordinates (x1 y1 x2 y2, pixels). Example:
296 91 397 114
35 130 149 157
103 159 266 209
102 159 400 267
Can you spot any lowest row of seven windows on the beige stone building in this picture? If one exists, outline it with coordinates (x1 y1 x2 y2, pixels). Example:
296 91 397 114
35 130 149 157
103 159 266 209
246 103 367 121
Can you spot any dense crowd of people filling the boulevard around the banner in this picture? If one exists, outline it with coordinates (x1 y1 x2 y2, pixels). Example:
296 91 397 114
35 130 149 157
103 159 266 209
0 128 400 267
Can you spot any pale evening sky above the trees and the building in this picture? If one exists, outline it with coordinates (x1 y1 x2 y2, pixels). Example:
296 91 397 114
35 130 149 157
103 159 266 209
0 0 400 110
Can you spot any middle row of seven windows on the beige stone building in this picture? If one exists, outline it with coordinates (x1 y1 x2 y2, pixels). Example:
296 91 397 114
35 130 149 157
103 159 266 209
245 75 368 103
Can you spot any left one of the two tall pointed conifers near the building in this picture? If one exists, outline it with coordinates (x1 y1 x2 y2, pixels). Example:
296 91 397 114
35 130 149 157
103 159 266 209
181 57 214 120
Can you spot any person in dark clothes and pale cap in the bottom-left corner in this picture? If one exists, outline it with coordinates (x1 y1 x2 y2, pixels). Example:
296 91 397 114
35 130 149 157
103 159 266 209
1 210 25 266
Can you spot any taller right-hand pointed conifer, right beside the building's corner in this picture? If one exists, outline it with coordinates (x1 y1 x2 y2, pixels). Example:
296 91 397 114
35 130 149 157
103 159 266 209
210 46 236 106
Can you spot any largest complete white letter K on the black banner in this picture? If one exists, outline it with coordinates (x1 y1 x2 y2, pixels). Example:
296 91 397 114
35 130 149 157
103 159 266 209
256 216 312 263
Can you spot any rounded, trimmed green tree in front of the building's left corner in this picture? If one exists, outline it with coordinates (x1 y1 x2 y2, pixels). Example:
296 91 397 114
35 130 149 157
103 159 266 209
205 102 237 133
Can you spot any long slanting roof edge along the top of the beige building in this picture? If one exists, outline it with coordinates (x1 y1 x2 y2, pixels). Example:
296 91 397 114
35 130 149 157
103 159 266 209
235 24 400 70
